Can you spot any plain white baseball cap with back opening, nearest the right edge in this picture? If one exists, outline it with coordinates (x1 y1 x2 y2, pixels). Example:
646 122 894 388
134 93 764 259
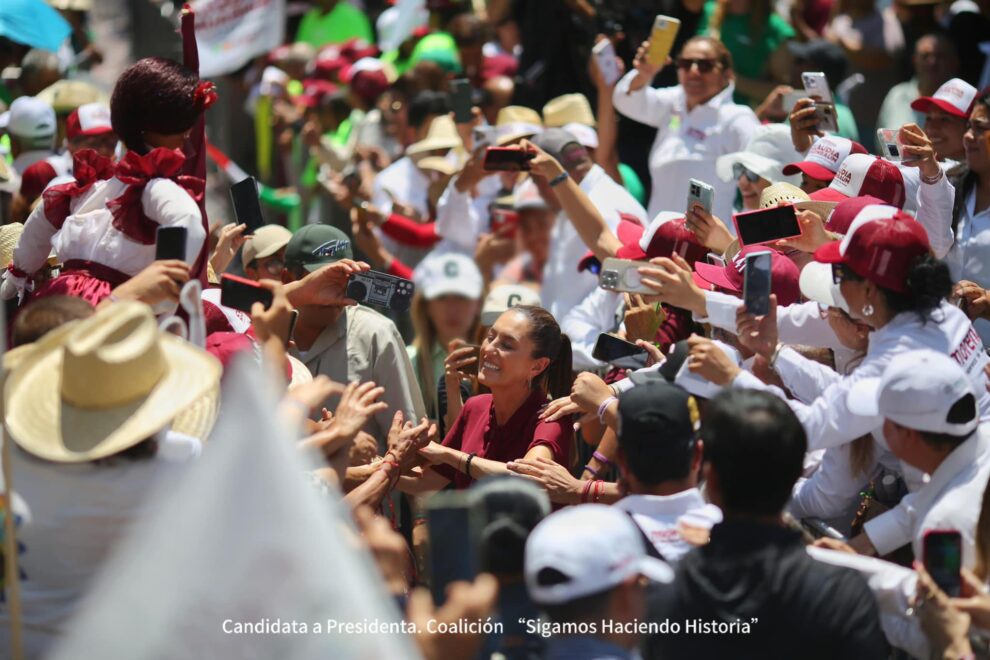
846 349 982 437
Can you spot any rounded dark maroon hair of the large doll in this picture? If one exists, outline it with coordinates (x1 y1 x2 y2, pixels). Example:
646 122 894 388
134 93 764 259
110 57 209 154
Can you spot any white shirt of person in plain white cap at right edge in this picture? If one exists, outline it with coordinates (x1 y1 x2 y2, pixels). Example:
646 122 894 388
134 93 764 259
863 424 990 568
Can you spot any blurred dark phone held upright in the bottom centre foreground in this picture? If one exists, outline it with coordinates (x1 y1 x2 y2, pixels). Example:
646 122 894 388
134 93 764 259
426 490 482 605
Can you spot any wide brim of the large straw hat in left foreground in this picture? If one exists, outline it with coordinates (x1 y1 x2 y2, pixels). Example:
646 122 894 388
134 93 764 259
4 334 222 463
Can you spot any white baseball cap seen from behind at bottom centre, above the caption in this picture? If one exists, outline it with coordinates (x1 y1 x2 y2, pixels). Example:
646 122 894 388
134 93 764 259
525 504 674 605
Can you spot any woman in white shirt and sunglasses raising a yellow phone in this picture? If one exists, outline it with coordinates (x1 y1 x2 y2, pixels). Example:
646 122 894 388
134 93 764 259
612 37 759 218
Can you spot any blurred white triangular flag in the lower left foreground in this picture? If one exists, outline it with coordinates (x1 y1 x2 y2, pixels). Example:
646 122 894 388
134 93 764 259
52 359 418 660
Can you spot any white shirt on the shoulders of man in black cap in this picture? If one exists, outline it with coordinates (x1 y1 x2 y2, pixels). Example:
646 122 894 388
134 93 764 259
614 488 722 563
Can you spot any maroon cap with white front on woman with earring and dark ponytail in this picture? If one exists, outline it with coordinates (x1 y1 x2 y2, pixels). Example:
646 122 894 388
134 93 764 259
815 206 930 293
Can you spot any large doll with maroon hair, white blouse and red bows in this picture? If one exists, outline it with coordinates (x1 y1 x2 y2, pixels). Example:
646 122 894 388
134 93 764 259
0 57 216 305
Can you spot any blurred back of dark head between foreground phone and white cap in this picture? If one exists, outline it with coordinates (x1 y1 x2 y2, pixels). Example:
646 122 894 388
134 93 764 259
471 475 550 576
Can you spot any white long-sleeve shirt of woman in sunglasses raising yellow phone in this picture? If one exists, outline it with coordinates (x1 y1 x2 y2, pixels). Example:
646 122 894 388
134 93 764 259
612 71 760 219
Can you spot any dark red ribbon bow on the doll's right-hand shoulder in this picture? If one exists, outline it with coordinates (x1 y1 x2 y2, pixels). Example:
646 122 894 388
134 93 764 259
107 147 206 245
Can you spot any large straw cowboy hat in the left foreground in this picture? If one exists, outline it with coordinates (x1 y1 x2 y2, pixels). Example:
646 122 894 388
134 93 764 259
4 301 221 463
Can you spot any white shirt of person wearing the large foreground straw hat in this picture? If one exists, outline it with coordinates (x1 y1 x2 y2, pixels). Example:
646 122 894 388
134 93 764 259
0 432 202 657
